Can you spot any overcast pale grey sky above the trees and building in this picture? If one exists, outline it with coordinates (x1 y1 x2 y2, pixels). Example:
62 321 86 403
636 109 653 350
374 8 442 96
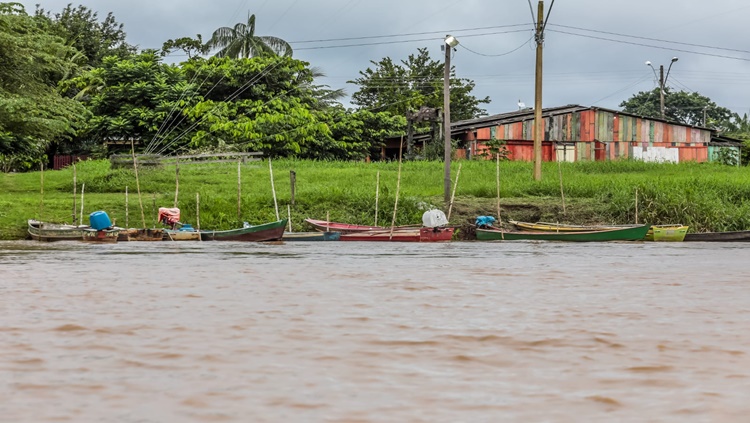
17 0 750 114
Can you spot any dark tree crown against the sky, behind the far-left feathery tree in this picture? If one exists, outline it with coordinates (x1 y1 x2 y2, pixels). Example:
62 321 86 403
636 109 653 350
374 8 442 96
35 3 136 67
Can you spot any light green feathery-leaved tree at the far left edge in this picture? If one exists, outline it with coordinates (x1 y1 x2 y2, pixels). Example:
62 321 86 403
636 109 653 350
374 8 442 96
0 3 87 162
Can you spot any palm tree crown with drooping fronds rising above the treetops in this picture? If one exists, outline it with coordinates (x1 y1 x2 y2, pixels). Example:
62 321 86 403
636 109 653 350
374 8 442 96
206 15 292 59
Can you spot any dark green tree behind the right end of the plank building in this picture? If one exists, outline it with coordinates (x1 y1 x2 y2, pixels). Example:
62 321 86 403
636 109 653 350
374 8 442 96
620 88 732 130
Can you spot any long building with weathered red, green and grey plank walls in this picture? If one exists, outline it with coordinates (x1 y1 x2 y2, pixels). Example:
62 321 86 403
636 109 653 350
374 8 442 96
451 105 739 162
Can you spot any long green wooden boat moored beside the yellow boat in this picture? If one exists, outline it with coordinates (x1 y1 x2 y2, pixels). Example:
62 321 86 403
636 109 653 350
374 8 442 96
477 225 651 242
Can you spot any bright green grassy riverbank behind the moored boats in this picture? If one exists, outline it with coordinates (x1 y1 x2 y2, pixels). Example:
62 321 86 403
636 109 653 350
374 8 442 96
0 160 750 239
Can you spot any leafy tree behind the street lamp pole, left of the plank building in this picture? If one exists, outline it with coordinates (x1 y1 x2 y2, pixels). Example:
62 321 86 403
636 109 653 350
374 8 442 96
348 48 490 121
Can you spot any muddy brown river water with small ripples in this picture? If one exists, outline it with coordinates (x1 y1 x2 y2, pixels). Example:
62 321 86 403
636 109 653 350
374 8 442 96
0 242 750 422
